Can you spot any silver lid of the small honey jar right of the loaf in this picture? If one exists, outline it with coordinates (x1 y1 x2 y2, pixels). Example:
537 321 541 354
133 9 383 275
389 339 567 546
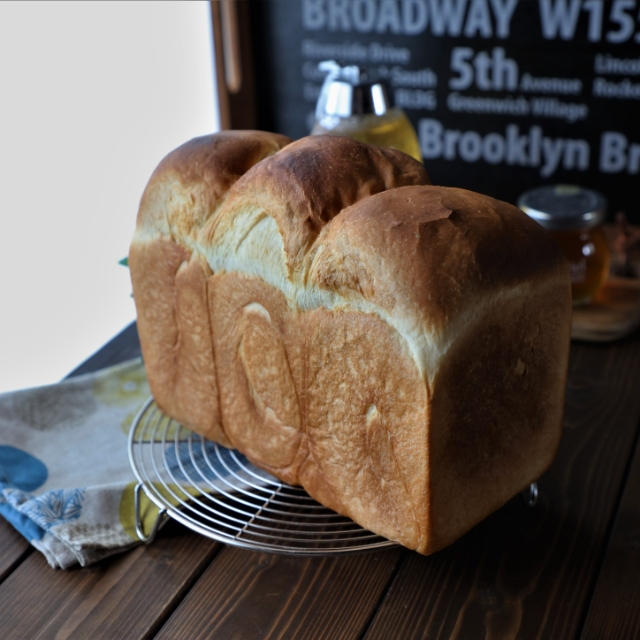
518 184 607 229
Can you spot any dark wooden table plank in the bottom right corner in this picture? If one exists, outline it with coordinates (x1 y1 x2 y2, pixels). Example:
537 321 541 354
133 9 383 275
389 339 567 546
582 432 640 640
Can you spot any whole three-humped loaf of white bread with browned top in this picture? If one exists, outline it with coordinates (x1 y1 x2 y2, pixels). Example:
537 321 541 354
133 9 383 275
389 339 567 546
129 131 571 553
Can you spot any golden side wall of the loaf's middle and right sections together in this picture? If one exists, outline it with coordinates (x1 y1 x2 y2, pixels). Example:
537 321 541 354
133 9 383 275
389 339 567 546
208 272 429 549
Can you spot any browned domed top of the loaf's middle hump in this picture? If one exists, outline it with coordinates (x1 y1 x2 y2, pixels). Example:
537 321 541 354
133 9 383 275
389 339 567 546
201 136 429 272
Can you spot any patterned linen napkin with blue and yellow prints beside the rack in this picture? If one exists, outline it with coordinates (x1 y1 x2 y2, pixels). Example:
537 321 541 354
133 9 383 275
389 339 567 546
0 358 158 569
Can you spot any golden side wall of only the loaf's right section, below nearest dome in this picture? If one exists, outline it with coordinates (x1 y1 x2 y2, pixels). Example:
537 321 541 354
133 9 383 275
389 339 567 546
298 309 430 551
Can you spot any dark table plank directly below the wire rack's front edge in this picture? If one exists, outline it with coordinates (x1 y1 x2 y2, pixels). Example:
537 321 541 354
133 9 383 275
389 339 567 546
156 548 403 640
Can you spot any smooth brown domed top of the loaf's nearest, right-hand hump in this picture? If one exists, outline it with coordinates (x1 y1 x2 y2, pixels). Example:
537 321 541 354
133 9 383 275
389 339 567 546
307 185 569 331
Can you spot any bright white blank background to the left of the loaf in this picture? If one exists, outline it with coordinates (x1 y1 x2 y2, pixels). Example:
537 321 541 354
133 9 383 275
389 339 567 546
0 2 219 392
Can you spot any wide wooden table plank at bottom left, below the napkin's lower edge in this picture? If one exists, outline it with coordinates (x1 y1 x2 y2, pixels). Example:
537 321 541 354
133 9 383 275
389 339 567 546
0 528 218 640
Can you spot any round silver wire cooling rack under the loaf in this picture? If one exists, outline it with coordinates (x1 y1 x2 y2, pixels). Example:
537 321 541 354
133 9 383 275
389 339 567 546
129 398 395 555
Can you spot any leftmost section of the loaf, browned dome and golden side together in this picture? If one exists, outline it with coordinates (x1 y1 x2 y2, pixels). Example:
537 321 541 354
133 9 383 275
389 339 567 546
129 131 290 445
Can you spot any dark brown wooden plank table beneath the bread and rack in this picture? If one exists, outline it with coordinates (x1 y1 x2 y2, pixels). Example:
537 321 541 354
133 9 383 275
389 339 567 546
0 325 640 640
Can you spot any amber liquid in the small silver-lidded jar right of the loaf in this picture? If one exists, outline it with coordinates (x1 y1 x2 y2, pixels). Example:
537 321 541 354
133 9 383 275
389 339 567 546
550 227 609 304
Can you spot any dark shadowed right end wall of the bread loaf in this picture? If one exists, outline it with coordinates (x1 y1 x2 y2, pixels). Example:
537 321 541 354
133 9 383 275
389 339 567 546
429 277 571 550
